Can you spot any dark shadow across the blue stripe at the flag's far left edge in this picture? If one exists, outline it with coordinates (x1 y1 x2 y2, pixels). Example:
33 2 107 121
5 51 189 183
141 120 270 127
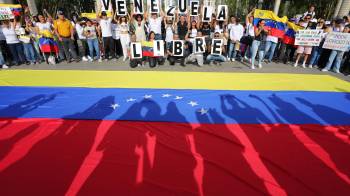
0 94 57 130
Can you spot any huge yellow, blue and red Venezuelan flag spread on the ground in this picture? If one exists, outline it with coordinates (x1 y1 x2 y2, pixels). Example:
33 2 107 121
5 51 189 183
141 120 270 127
0 70 350 196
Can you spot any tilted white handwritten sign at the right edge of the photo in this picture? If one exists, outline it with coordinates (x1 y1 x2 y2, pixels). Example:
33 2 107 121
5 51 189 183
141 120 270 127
323 32 350 52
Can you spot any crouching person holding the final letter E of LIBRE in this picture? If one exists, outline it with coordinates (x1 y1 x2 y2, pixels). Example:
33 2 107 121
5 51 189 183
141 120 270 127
207 32 226 64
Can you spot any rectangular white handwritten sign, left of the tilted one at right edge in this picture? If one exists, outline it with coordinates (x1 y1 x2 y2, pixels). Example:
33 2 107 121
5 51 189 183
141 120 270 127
295 30 323 46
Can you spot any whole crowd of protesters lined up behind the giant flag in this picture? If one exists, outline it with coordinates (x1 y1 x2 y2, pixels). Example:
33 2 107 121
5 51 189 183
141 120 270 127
0 5 350 74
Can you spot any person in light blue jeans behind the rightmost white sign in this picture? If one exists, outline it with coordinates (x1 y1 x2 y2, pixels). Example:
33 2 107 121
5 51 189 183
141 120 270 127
322 26 350 73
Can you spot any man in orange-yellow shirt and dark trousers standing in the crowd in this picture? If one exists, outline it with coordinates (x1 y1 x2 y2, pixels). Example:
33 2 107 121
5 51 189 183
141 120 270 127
54 11 79 63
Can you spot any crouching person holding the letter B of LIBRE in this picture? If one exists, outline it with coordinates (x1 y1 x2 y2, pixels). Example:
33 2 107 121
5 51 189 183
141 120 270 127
167 34 185 67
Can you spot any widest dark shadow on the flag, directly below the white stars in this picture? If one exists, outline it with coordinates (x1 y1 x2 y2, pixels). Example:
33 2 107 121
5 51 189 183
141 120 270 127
79 100 197 195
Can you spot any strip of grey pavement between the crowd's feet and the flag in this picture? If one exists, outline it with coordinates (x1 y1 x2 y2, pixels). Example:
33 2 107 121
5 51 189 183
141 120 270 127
3 60 350 82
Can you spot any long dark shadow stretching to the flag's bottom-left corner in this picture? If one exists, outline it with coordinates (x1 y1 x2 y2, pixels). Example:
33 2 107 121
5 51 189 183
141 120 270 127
0 96 114 195
